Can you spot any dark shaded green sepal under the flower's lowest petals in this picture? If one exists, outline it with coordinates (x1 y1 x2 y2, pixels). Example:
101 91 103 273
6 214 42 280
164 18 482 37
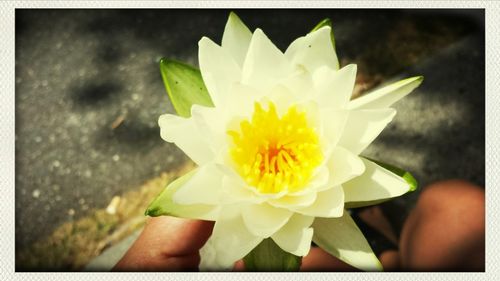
243 238 302 271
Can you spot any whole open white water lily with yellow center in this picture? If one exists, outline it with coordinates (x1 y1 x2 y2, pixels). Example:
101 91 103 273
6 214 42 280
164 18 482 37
159 14 422 270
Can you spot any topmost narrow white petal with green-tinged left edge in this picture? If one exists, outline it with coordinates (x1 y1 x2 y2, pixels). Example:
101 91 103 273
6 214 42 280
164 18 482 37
222 12 252 67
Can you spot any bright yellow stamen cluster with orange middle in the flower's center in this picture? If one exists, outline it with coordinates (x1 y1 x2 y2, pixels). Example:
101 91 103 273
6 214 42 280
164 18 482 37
227 102 323 193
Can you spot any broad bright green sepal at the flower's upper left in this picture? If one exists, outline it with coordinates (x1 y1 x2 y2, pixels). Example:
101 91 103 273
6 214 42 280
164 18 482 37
160 58 213 117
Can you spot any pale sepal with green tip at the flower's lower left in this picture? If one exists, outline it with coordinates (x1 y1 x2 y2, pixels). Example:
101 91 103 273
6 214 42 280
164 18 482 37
145 169 215 220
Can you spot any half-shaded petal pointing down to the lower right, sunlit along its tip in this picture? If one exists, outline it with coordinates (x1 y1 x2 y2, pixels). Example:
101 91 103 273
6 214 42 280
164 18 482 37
313 212 382 271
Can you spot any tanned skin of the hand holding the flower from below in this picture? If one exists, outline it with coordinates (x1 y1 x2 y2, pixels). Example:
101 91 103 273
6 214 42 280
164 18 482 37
113 216 355 271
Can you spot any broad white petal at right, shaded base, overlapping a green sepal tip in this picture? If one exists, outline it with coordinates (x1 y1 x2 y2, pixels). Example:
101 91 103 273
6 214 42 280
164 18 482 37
342 158 410 206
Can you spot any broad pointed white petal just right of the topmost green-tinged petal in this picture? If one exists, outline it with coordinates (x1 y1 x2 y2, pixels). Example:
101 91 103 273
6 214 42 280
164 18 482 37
242 29 292 91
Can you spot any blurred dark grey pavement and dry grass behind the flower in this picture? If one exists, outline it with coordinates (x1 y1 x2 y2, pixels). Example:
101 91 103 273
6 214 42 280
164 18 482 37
15 9 485 271
